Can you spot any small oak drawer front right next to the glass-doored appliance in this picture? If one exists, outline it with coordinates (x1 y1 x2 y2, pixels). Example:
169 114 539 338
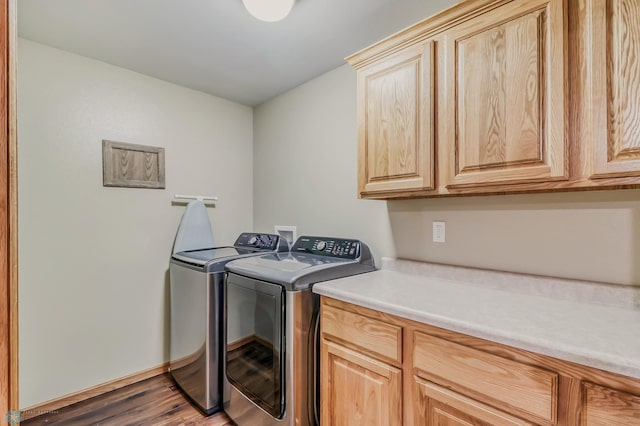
320 305 402 363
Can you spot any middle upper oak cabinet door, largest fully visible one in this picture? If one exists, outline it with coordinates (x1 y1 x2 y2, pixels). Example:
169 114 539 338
438 0 568 189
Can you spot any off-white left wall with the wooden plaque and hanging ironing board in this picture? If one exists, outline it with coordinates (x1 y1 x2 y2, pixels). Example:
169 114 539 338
18 40 253 407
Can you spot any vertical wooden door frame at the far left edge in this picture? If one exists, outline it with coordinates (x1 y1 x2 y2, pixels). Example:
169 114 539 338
0 0 20 425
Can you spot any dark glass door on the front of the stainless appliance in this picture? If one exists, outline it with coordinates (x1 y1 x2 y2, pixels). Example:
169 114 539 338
225 273 285 418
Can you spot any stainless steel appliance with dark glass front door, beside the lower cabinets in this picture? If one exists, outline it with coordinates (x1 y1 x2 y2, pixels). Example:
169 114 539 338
224 237 375 426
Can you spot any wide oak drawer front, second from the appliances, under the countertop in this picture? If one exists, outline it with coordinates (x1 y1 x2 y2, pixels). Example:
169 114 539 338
413 332 558 423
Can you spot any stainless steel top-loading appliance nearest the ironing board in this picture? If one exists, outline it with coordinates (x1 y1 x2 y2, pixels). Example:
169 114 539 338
169 233 288 414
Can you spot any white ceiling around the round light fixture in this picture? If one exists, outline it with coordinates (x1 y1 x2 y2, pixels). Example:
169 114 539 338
18 0 456 106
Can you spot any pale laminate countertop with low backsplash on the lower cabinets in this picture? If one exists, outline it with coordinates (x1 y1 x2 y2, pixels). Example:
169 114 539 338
313 258 640 379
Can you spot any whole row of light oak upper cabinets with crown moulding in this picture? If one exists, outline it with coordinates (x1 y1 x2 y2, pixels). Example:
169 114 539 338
347 0 640 199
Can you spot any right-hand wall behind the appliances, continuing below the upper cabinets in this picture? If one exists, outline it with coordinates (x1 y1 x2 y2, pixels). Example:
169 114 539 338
254 65 640 284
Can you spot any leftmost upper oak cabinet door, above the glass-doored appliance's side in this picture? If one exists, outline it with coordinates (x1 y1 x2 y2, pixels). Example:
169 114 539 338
358 41 434 197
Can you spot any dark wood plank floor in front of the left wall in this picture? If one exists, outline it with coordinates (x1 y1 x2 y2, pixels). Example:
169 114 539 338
20 374 233 426
